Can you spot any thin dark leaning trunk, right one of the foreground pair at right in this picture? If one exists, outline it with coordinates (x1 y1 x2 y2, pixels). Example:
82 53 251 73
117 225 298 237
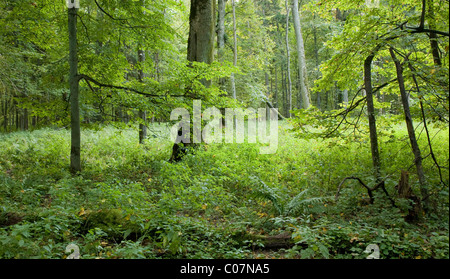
389 48 428 208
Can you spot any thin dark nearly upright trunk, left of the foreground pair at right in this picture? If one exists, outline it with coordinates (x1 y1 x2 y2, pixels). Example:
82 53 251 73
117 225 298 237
364 54 381 182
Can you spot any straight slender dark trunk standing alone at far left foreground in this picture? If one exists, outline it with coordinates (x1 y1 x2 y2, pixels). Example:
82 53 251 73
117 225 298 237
68 8 81 173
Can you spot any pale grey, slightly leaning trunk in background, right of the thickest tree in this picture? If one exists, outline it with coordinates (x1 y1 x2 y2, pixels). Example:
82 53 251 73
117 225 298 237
292 0 311 109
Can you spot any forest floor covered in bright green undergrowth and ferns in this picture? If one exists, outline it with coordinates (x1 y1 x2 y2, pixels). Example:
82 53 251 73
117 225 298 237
0 123 449 259
